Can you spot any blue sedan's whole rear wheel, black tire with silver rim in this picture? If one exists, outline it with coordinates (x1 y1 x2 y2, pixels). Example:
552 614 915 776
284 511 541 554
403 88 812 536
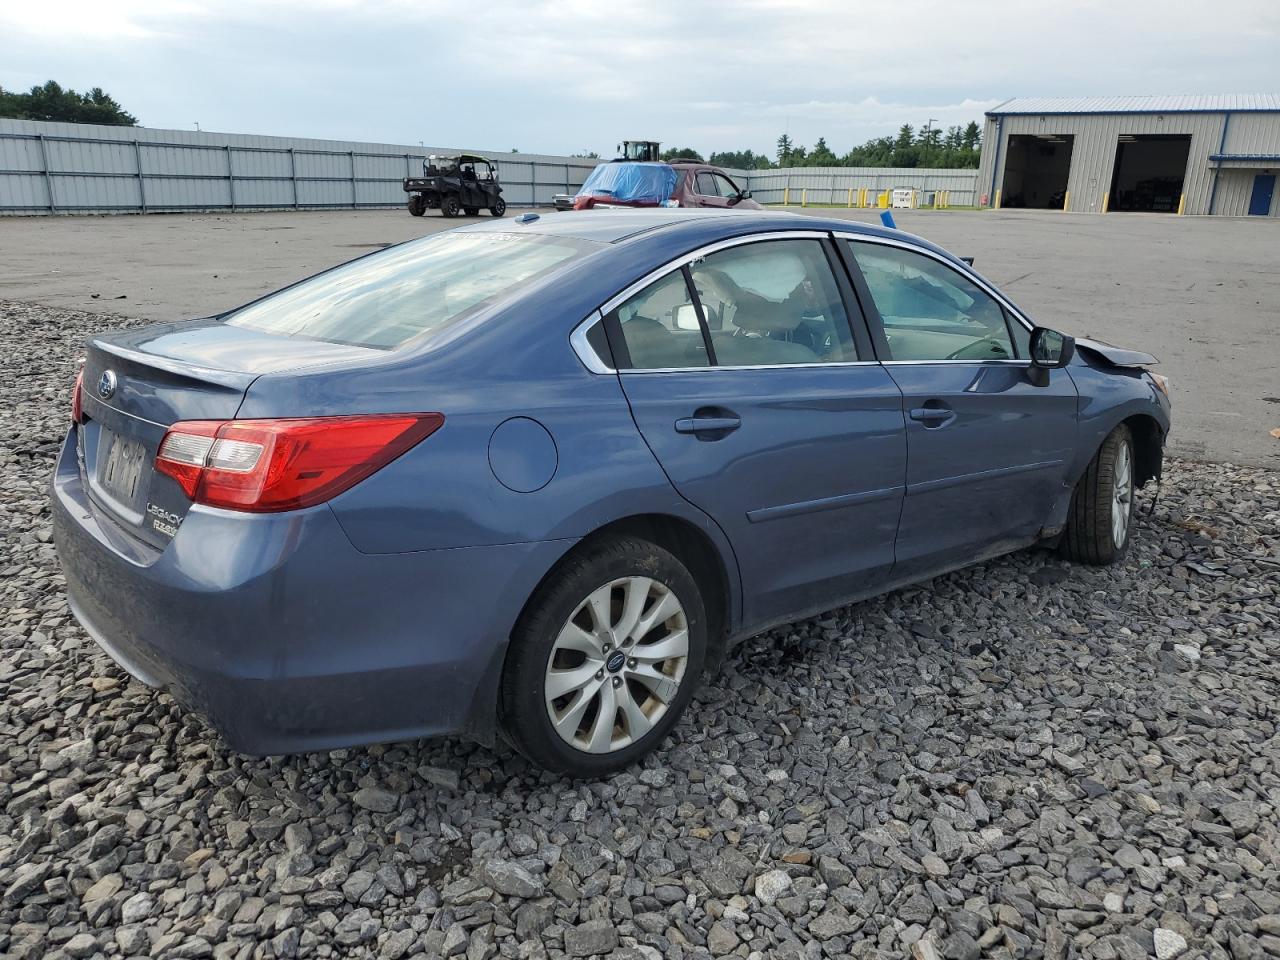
500 538 707 778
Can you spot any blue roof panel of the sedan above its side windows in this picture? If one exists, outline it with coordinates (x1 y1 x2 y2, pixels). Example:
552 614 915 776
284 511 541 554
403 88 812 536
460 207 937 250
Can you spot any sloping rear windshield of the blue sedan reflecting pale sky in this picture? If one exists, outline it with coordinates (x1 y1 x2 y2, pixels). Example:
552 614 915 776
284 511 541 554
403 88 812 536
223 233 591 349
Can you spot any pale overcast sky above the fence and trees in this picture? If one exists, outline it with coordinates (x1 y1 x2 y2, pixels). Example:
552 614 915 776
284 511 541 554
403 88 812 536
0 0 1280 156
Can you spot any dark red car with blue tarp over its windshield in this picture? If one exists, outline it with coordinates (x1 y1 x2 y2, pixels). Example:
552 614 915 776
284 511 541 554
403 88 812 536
573 160 764 210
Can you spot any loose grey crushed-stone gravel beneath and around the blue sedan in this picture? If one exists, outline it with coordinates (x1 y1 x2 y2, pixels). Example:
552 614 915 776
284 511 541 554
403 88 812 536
0 303 1280 960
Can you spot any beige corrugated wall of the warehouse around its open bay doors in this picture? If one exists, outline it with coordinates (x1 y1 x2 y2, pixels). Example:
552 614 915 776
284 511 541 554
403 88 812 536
978 113 1280 216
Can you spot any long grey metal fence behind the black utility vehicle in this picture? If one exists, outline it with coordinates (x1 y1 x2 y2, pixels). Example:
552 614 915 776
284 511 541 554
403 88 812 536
0 119 598 214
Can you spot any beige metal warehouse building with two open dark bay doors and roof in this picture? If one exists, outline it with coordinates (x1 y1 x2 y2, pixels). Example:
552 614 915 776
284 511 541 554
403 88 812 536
978 93 1280 216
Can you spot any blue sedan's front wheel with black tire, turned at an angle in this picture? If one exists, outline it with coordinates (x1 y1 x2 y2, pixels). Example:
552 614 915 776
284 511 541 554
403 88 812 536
1059 424 1137 566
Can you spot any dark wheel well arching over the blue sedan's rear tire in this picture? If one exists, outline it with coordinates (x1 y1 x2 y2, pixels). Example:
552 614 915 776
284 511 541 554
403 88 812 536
544 513 732 672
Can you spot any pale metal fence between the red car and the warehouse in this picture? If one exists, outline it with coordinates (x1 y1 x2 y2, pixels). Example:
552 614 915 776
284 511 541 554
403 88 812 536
748 166 978 206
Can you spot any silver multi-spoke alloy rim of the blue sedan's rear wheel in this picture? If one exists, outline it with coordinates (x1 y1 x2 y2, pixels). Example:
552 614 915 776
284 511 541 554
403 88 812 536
543 576 689 754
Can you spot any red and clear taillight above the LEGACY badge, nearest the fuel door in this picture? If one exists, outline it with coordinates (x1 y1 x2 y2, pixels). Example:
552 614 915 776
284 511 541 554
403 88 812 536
156 413 444 513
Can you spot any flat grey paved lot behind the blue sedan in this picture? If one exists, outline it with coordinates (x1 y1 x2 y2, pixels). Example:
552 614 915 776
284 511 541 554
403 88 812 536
0 209 1280 466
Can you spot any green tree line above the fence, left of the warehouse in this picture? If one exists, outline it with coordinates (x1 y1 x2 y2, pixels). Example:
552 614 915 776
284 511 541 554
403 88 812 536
662 120 982 170
